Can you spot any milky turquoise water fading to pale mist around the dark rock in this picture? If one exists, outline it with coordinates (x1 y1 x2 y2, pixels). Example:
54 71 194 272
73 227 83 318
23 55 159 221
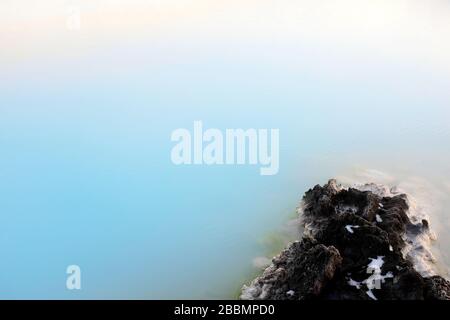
0 0 450 299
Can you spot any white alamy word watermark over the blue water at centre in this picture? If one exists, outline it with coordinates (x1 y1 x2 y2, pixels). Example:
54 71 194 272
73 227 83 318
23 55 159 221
171 121 280 175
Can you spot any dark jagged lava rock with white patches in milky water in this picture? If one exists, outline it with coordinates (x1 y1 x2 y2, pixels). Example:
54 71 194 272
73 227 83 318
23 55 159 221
241 180 450 300
